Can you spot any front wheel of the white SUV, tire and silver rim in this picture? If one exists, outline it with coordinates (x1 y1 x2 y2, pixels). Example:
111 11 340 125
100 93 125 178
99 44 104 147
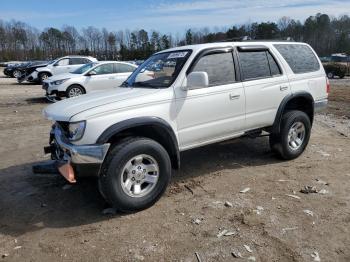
99 137 171 212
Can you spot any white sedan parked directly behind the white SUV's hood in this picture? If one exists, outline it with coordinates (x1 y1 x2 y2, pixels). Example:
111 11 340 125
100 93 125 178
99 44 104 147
43 61 137 102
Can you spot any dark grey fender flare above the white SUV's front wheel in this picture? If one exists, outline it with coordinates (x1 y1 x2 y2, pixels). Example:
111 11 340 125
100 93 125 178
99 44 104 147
96 117 180 169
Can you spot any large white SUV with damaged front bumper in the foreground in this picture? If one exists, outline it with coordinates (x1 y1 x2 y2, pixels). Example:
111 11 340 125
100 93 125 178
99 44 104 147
44 42 329 212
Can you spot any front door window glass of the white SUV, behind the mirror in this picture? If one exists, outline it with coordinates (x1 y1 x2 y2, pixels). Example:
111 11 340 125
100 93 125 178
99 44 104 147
192 52 235 86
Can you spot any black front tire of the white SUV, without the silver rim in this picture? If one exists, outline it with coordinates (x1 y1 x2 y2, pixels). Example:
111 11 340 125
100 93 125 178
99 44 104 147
99 137 171 213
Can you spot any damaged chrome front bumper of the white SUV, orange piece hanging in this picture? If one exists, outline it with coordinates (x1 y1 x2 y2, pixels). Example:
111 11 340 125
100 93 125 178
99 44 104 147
45 123 110 183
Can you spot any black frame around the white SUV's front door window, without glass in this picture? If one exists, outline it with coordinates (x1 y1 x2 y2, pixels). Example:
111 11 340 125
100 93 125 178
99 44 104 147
186 46 241 89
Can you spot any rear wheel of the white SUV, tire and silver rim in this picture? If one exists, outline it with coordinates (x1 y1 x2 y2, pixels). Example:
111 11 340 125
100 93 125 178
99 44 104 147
270 110 311 160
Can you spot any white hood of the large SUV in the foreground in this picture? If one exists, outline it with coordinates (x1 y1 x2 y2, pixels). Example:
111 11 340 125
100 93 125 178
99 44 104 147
43 88 159 121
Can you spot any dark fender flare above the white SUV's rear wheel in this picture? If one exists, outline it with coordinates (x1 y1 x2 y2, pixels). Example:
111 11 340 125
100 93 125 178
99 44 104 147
271 92 314 134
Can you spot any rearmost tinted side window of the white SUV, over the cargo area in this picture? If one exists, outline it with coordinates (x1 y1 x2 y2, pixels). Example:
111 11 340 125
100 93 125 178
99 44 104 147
274 44 320 74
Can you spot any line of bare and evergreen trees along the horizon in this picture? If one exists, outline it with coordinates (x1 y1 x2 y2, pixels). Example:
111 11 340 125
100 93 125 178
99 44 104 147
0 14 350 61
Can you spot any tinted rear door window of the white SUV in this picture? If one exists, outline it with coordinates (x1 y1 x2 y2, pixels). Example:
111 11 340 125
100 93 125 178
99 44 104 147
239 51 281 80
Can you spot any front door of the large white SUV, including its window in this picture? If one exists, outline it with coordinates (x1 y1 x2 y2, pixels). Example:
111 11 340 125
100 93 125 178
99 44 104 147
175 49 245 150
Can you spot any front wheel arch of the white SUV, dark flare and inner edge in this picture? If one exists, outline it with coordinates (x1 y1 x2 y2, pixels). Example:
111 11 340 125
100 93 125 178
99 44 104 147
97 117 180 169
